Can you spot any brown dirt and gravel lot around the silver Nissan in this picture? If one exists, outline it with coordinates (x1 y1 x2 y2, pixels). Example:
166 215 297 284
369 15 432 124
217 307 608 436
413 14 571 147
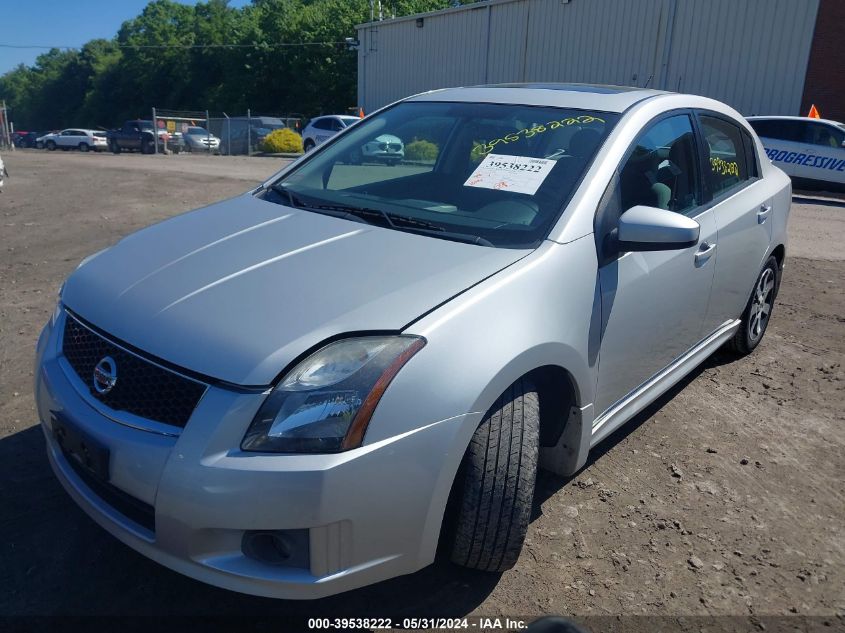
0 150 845 630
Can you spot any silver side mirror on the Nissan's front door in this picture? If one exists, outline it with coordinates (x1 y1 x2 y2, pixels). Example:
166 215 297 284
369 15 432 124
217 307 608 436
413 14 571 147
617 205 701 251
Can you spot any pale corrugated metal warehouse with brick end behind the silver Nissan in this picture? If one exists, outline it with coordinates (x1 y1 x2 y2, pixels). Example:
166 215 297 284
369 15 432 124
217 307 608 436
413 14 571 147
357 0 845 120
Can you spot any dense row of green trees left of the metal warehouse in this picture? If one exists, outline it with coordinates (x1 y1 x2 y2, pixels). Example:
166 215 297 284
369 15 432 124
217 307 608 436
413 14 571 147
0 0 474 129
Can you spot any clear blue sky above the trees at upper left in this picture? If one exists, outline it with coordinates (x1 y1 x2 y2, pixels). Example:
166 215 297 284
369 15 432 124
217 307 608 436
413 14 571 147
0 0 249 75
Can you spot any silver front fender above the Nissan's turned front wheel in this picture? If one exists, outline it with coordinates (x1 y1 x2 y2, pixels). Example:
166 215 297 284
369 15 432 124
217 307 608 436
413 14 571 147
365 236 601 462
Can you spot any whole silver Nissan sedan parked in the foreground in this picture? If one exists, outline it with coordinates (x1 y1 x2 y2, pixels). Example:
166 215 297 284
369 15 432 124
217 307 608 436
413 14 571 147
35 84 791 598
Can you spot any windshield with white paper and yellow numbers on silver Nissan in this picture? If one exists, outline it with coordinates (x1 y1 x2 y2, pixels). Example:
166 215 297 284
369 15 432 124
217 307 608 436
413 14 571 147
263 102 619 248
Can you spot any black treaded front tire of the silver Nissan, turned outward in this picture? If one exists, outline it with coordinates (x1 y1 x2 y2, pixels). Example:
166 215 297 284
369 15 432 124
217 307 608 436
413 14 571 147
451 378 540 572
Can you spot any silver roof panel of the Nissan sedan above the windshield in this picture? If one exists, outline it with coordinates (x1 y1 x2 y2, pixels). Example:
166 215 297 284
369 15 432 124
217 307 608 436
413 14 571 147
408 83 669 112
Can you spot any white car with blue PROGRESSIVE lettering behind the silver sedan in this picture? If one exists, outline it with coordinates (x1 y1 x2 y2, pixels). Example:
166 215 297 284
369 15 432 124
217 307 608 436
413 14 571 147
748 116 845 192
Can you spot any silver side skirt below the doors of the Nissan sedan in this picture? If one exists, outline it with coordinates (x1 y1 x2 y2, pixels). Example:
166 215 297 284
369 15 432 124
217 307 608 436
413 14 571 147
590 319 740 448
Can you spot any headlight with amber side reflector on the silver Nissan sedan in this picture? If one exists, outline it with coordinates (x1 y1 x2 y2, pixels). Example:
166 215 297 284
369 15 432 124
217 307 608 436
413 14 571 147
241 336 425 453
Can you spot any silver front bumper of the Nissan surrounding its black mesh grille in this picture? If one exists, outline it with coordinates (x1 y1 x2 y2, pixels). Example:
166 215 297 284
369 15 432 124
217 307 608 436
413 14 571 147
35 315 477 599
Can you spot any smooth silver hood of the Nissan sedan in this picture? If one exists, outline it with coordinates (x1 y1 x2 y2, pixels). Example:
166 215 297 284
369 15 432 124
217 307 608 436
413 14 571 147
62 194 526 385
